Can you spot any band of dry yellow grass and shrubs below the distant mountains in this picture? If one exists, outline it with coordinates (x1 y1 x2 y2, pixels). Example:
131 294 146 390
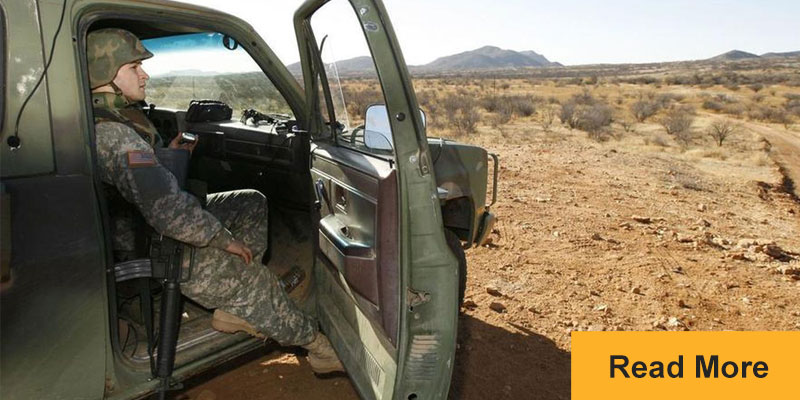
330 60 800 173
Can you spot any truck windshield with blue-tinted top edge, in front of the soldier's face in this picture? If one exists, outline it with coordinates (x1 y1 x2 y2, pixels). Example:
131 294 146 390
142 32 292 119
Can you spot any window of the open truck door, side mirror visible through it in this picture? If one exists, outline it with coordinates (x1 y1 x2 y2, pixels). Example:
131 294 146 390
311 0 393 154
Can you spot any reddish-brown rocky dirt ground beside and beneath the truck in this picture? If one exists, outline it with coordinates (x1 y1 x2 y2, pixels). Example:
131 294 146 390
179 115 800 400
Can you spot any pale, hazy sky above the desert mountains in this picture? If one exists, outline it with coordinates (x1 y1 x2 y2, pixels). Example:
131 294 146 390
184 0 800 65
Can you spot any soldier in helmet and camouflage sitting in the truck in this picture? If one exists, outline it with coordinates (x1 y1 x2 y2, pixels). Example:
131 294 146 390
87 29 344 374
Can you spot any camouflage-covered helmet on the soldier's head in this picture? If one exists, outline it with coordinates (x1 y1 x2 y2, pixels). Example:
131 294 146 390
86 28 153 89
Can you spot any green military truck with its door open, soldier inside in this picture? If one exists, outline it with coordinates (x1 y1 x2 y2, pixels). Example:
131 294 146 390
0 0 498 399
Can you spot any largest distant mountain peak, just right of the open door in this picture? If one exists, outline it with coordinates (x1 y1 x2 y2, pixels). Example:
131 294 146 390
417 46 560 71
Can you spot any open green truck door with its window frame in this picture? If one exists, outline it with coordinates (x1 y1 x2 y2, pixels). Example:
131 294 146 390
294 0 458 399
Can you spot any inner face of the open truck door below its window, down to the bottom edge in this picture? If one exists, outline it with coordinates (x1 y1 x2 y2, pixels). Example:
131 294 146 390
311 146 399 399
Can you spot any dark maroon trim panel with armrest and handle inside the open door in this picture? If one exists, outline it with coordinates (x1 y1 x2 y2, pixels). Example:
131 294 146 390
311 146 398 346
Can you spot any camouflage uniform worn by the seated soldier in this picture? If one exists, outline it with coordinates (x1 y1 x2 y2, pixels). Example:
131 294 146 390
89 30 317 345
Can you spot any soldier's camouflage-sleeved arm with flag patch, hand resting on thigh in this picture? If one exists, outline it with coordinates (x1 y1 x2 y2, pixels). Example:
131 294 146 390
95 122 233 250
